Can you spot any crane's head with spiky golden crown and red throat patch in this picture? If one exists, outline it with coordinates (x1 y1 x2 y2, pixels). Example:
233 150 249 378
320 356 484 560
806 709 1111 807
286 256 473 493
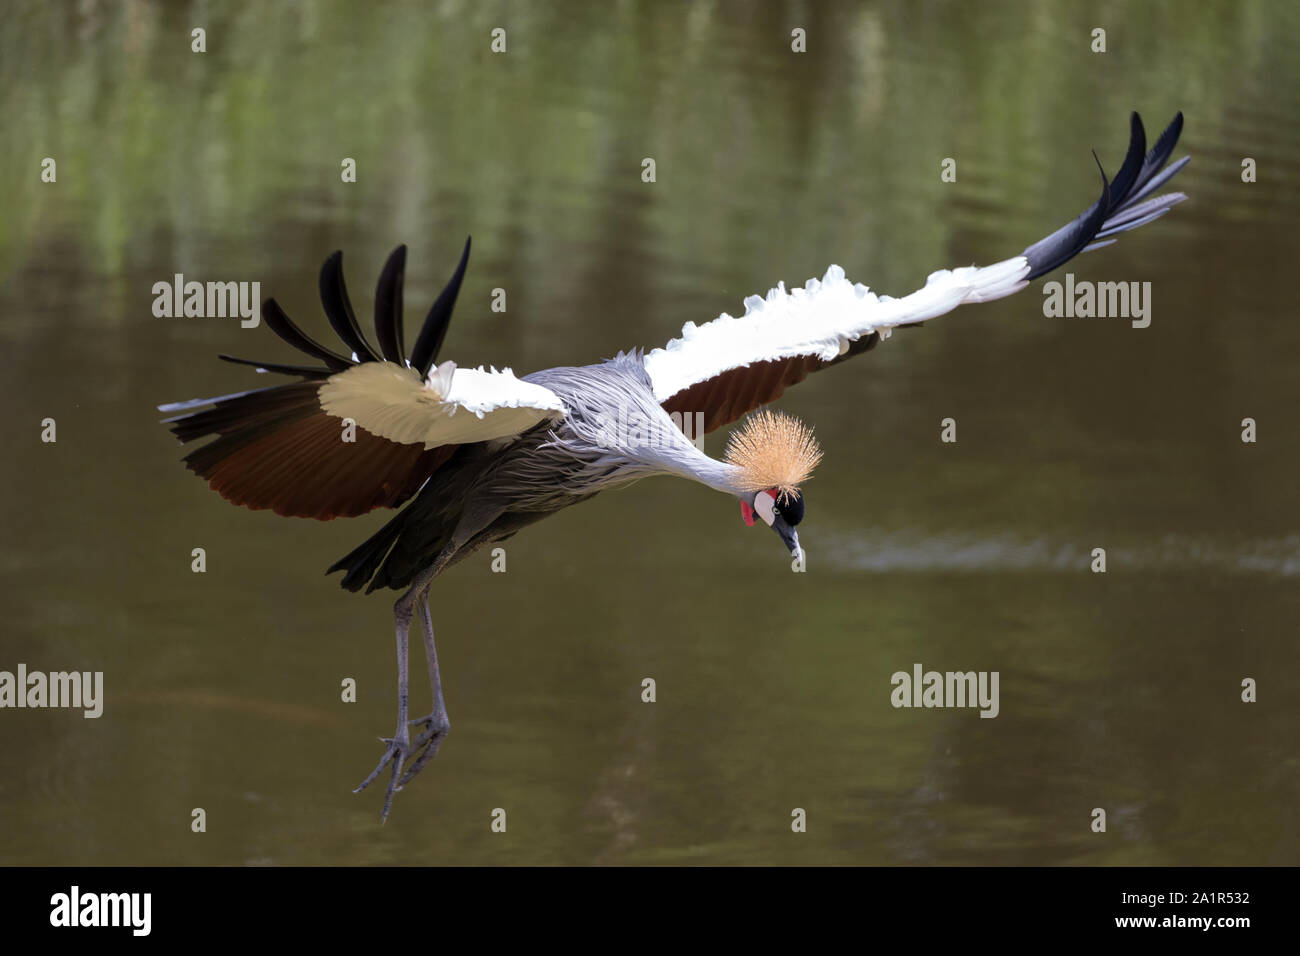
727 410 822 554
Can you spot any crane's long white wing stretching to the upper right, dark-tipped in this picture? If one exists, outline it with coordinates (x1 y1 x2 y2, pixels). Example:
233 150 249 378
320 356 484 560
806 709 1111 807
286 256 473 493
645 113 1190 432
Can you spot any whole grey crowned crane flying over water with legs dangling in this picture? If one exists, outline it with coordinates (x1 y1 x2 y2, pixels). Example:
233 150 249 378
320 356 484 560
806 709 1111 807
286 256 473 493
160 113 1188 819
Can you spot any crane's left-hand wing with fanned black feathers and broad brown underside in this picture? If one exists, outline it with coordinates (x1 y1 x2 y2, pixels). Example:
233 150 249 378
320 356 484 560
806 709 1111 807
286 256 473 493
159 241 563 520
